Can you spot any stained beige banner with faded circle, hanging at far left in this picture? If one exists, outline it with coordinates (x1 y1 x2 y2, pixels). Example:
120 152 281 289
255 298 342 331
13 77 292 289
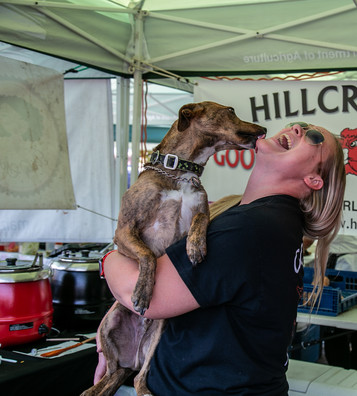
0 57 76 209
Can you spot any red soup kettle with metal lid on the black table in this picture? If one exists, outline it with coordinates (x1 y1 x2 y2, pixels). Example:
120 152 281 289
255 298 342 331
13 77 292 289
0 255 53 347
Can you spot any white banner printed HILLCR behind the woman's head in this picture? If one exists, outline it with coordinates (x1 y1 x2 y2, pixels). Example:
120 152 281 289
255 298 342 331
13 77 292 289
194 80 357 235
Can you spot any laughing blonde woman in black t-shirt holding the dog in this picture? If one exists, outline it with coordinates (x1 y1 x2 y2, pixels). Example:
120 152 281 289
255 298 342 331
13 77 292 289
101 122 345 396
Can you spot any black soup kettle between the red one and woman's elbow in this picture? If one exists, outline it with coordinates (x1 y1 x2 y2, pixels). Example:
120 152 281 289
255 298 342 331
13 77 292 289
50 250 114 327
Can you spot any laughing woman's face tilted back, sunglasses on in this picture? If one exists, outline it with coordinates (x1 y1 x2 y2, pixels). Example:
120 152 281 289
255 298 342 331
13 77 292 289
256 124 335 177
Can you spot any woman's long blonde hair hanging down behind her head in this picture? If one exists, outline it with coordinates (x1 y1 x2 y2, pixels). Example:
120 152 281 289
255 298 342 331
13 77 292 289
210 130 346 307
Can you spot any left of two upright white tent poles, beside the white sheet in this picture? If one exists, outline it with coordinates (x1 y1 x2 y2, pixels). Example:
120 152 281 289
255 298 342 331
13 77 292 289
114 77 130 217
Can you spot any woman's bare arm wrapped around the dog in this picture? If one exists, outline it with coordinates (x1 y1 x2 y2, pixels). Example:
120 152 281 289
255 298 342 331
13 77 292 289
104 251 199 319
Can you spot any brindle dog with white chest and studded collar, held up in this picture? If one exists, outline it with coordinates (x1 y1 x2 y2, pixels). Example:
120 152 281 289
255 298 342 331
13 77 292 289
82 102 266 396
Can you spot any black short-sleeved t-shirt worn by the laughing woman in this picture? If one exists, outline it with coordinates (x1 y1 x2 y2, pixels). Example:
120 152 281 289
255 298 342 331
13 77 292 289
148 195 303 396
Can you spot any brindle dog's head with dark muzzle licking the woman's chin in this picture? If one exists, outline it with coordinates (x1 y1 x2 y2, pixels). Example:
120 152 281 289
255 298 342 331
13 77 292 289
177 101 266 151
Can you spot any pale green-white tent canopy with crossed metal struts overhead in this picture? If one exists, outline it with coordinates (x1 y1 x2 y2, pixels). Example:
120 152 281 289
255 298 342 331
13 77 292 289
0 0 357 87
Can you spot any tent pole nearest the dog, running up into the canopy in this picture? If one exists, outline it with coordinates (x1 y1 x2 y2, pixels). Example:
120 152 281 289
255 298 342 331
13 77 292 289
130 12 144 186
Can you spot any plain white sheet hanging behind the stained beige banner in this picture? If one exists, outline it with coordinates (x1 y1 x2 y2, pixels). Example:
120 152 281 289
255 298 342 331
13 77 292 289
0 79 117 243
